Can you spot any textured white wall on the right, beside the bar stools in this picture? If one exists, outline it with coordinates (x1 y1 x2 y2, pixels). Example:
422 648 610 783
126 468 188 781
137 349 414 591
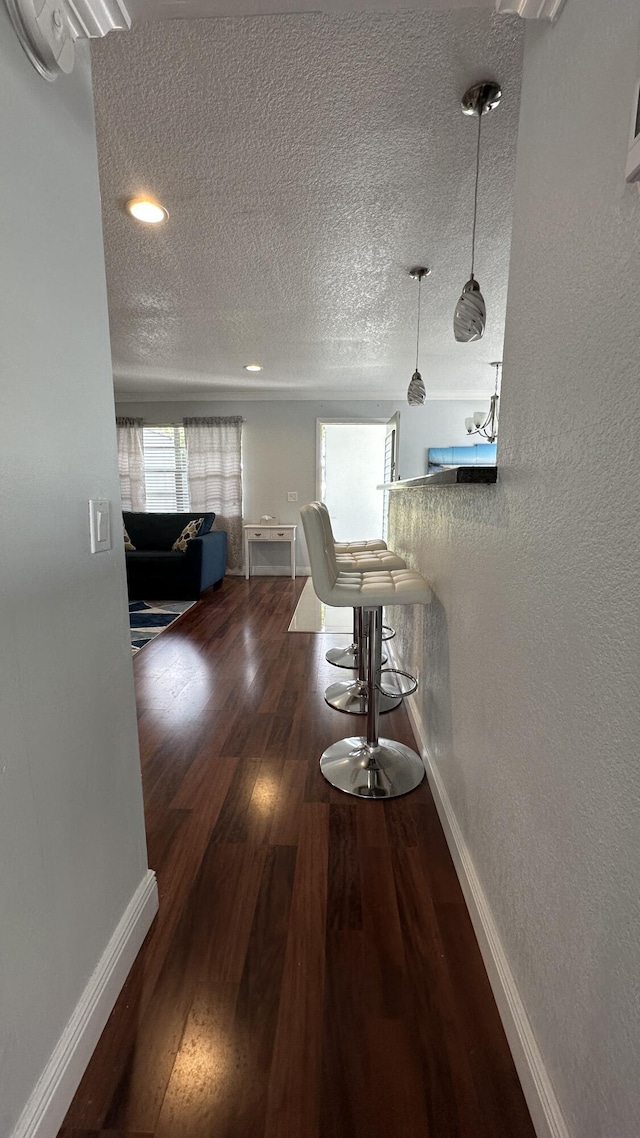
392 0 640 1138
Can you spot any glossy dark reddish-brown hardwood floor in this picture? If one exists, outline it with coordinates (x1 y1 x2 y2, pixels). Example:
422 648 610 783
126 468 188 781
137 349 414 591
59 577 534 1138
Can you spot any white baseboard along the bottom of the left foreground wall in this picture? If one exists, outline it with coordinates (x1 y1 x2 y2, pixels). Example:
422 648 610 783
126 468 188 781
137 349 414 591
11 869 158 1138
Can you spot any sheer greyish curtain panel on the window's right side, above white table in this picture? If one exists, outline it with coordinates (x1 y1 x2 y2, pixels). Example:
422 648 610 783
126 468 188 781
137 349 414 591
184 415 243 572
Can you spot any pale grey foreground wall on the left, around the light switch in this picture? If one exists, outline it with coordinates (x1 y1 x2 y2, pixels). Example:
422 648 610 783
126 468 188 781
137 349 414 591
0 17 147 1136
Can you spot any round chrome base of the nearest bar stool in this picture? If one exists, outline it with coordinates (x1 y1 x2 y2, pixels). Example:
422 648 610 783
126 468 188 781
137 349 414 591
320 735 425 798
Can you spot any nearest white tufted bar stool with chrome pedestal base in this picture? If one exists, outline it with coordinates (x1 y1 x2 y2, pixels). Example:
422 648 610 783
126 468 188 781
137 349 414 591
301 505 432 798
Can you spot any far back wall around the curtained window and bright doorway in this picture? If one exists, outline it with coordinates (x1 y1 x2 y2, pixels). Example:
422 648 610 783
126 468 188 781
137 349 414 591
117 397 489 572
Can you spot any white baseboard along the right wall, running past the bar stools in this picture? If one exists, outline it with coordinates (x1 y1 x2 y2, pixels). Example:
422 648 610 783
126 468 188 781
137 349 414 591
392 664 571 1138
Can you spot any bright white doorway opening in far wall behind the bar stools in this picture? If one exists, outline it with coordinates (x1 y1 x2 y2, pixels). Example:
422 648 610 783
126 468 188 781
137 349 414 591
317 419 387 542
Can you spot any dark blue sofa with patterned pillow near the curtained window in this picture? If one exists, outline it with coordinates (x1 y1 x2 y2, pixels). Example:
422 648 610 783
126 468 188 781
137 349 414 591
122 511 227 601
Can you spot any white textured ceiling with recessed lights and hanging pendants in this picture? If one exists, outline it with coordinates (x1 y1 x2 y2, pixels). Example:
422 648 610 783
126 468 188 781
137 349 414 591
92 5 523 398
